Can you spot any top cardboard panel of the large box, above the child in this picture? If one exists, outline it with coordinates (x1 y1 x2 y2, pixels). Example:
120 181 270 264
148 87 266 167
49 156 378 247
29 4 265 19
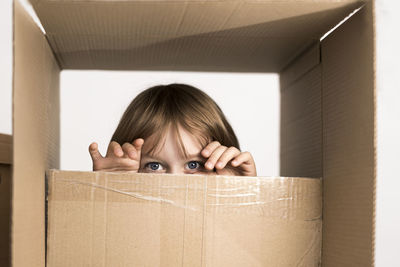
33 0 362 72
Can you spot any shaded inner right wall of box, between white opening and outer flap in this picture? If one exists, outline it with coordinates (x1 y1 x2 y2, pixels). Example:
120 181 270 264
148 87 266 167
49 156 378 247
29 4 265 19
280 56 322 180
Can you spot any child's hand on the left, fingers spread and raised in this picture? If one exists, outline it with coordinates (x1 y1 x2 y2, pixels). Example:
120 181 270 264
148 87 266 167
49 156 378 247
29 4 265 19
89 138 144 172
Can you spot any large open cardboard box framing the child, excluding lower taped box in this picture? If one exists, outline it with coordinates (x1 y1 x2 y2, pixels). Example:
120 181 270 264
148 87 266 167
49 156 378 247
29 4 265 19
11 0 376 266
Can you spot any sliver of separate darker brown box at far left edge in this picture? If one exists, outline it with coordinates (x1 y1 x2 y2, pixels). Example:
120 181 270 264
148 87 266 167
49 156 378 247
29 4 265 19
0 134 12 266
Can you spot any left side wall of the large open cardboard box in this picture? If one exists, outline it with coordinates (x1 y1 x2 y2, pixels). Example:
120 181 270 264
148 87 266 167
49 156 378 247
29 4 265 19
12 1 60 266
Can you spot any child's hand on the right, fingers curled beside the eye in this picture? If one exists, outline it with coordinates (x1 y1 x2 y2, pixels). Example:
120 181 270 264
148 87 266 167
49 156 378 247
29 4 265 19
201 141 257 176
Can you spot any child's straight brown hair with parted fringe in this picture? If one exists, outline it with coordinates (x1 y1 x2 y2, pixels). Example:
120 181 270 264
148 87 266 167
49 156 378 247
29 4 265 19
111 84 240 155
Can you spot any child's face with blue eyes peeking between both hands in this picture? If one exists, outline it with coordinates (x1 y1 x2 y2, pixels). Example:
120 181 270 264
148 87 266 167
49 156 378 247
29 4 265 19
139 127 213 174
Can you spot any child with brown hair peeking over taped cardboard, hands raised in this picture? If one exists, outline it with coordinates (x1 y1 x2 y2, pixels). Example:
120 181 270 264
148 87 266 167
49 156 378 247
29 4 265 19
89 84 257 176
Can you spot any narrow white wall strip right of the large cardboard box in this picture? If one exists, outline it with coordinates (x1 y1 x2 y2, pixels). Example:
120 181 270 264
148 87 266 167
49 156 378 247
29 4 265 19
375 0 400 267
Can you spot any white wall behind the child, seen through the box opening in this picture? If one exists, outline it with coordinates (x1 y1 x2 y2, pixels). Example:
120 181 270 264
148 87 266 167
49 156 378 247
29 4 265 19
61 71 280 176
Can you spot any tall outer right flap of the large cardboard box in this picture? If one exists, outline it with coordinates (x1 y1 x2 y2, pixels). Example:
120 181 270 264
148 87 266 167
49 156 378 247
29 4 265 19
321 4 376 266
